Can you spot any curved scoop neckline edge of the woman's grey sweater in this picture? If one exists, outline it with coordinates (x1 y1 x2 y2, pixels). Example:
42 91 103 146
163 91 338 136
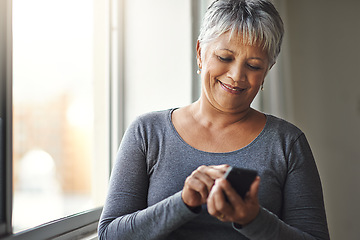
167 108 270 155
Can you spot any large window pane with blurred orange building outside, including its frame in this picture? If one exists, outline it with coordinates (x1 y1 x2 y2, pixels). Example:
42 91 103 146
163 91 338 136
0 0 112 239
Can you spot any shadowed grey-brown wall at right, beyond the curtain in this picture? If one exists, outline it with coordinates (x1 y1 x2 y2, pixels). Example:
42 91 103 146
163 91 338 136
283 0 360 240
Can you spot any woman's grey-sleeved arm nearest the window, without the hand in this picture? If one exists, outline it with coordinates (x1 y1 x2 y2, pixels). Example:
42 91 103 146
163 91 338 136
98 120 197 239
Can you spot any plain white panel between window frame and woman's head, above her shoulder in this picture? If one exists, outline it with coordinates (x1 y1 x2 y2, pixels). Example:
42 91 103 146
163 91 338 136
124 0 195 125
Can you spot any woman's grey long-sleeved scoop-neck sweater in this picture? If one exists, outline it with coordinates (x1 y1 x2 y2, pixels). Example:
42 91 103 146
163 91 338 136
98 110 329 240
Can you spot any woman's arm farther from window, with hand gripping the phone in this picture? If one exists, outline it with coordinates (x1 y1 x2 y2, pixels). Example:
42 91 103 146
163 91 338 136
208 135 329 240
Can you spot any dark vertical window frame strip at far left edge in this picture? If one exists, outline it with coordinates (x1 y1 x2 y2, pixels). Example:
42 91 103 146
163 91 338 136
0 0 12 236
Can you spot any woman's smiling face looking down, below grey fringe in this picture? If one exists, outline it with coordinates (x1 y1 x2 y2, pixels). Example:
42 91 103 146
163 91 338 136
197 33 269 113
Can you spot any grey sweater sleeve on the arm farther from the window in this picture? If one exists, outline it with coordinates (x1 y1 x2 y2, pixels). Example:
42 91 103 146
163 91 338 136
235 134 329 240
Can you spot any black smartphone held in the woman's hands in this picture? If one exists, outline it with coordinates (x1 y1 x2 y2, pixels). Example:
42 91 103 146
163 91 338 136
224 166 258 198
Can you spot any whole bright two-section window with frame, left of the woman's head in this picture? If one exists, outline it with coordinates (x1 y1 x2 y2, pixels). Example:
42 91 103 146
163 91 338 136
0 0 206 240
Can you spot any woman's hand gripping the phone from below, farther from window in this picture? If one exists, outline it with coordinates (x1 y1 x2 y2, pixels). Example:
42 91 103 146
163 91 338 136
207 177 260 226
